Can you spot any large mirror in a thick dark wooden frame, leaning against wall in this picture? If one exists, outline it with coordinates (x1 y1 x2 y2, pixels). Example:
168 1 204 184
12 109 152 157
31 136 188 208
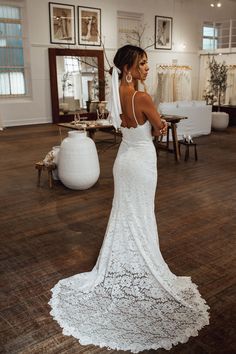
49 48 105 123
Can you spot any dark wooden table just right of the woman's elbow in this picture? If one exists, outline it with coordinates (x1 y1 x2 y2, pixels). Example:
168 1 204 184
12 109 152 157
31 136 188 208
158 114 188 161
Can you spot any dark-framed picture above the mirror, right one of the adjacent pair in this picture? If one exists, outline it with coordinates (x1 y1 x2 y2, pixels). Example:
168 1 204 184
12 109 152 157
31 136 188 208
78 6 101 46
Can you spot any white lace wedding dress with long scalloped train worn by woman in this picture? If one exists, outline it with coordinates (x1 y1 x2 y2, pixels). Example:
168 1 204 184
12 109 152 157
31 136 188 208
49 92 209 353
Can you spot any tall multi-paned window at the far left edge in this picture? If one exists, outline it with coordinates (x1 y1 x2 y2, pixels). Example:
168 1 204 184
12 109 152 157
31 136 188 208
0 5 27 97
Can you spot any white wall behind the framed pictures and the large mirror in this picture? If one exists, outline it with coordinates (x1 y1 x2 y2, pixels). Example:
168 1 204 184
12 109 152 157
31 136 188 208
0 0 236 126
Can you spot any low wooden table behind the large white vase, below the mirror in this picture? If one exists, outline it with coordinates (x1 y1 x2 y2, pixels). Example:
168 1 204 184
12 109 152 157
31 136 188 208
57 121 114 140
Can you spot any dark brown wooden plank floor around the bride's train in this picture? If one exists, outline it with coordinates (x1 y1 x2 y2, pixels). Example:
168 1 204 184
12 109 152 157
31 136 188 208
0 124 236 354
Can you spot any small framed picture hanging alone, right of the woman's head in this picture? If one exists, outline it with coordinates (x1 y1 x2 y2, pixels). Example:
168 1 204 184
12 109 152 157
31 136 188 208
155 16 173 49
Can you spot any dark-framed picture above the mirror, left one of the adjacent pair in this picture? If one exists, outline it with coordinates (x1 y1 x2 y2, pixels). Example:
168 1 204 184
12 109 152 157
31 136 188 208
49 2 75 44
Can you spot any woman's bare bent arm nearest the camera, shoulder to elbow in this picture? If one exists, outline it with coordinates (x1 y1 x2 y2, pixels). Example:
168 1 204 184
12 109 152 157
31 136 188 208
139 92 167 136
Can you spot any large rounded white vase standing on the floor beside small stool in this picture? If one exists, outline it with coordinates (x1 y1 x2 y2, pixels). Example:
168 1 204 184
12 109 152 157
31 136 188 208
58 131 100 189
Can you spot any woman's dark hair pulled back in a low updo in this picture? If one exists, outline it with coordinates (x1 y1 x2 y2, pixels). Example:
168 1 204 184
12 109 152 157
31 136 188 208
110 44 147 78
